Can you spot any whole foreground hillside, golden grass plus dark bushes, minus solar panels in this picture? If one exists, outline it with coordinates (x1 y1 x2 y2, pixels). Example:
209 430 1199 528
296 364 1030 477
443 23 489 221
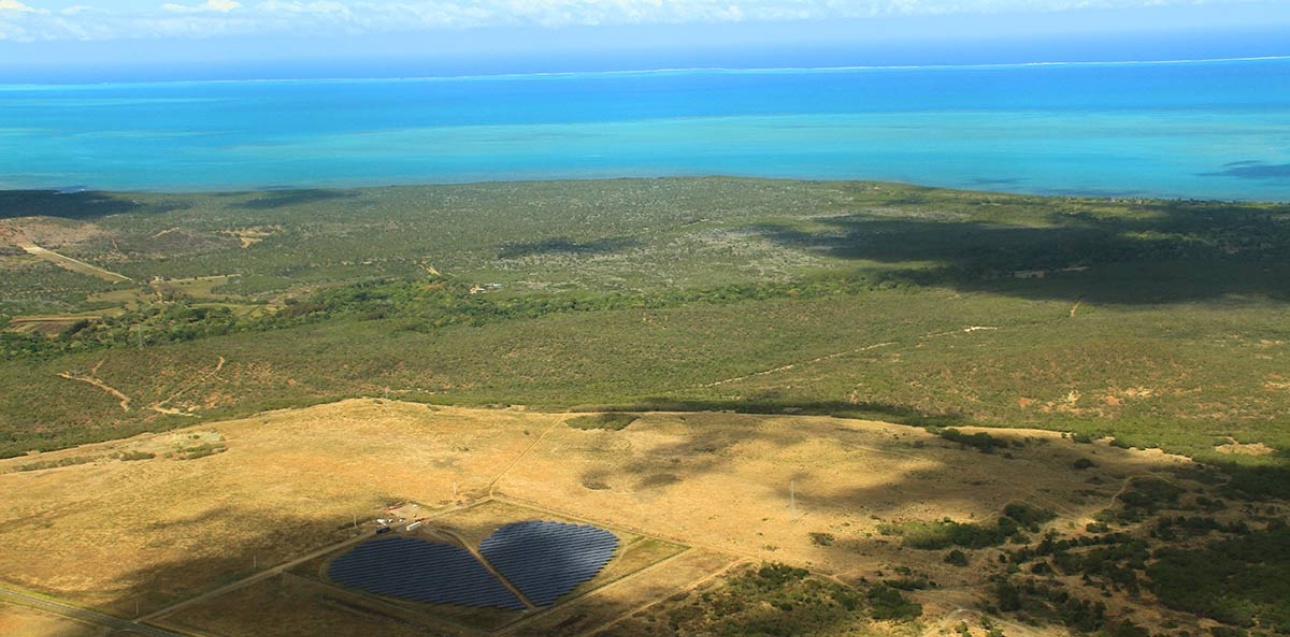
0 400 1290 637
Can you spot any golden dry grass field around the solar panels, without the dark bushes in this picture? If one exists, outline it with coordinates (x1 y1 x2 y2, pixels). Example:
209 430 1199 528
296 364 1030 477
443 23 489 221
0 400 1207 637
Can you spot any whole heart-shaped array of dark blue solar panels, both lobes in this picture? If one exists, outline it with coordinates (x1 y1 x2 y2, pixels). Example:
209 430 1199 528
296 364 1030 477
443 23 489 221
328 520 618 610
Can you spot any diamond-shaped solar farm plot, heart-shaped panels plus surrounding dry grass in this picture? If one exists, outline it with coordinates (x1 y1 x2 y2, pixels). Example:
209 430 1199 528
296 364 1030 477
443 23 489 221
264 495 696 636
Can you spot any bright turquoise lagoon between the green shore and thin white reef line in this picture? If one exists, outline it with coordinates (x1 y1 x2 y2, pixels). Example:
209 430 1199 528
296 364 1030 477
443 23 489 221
0 58 1290 201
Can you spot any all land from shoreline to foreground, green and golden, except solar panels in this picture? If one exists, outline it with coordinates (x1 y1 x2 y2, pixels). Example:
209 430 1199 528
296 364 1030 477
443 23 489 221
0 178 1290 637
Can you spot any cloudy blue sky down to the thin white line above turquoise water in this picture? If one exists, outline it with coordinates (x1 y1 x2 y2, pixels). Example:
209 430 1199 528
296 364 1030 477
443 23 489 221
0 0 1290 81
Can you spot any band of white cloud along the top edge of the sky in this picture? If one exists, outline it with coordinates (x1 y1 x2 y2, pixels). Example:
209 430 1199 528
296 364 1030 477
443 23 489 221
0 0 1286 40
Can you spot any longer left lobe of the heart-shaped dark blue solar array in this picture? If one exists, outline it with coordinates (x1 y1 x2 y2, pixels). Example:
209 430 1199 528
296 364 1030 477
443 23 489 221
328 536 524 610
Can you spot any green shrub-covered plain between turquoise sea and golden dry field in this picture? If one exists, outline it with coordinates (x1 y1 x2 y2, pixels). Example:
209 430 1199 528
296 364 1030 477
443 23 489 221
0 178 1290 471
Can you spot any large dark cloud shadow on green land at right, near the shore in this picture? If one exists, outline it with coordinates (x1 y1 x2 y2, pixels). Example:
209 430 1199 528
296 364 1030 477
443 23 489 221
753 191 1290 304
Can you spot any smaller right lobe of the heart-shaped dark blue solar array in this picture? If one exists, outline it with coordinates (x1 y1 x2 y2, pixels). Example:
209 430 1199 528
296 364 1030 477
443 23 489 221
480 520 618 606
